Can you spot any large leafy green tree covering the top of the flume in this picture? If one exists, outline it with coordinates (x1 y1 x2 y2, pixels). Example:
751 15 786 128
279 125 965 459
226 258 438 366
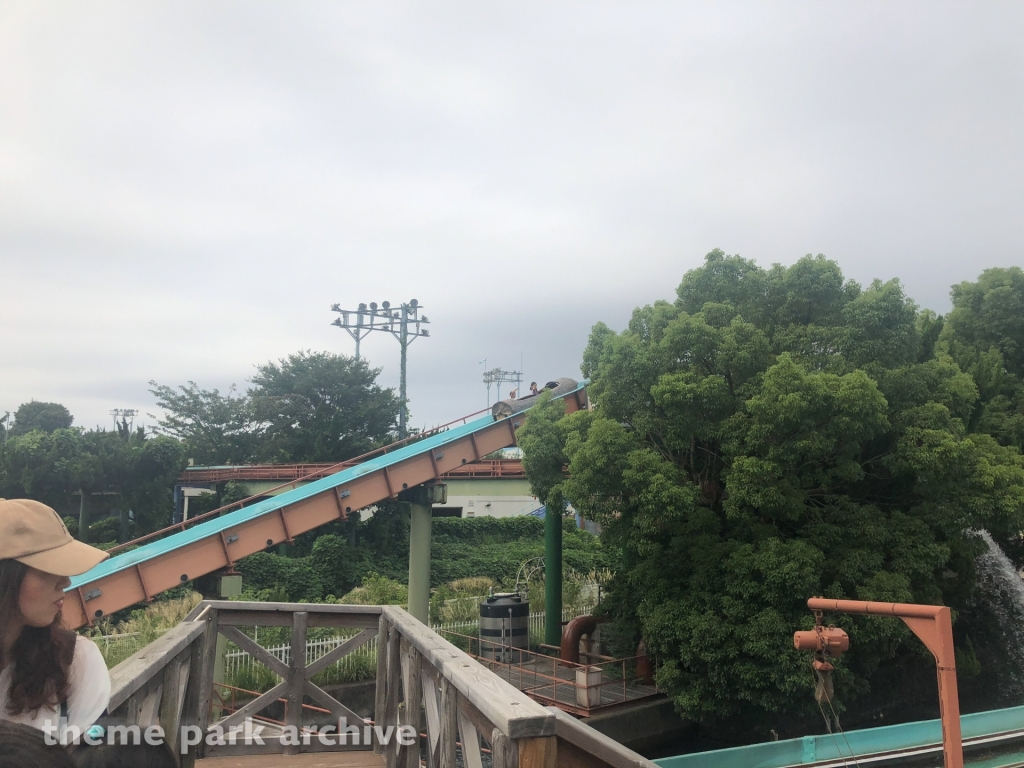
521 251 1024 727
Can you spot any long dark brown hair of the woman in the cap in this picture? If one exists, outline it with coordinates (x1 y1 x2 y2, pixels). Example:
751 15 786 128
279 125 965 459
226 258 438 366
0 559 75 715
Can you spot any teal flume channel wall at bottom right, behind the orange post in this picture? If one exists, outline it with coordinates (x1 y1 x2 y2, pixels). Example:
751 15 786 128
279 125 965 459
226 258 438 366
654 707 1024 768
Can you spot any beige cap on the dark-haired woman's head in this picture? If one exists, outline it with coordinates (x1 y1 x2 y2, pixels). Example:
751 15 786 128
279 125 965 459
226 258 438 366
0 499 110 577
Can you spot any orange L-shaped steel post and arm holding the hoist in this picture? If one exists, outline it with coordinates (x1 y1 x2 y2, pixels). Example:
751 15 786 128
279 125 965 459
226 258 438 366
807 597 964 768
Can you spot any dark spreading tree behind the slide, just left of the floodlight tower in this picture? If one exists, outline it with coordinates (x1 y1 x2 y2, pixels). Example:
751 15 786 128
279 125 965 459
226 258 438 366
250 351 398 462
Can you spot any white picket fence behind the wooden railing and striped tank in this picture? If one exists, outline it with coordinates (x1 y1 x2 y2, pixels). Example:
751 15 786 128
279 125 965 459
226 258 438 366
224 605 594 680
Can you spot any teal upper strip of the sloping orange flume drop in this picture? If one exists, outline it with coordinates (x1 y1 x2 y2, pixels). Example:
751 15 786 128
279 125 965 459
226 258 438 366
68 382 586 591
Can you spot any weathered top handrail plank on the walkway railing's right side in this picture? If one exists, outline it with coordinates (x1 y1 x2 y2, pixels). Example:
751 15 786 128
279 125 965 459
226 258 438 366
384 606 555 739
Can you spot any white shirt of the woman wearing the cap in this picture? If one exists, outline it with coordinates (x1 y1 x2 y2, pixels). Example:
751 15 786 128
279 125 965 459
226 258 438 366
0 635 111 736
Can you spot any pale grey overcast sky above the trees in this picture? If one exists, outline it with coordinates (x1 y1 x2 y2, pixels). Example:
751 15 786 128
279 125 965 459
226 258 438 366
0 0 1024 436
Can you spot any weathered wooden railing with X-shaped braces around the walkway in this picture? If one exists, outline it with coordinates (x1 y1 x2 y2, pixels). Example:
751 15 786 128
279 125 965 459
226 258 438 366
111 601 653 768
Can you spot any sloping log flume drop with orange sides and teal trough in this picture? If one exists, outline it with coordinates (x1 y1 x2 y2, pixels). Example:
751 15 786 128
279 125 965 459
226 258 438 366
63 379 587 629
